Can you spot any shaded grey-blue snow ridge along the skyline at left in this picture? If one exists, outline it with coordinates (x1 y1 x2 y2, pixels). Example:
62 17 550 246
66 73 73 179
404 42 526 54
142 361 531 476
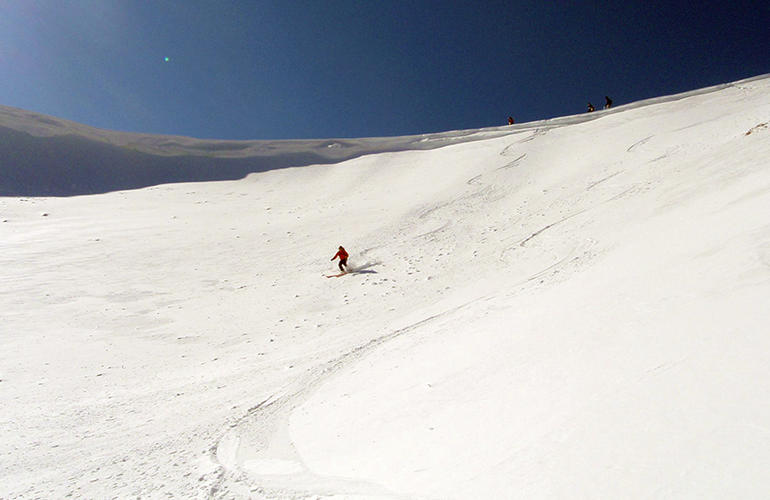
0 106 520 196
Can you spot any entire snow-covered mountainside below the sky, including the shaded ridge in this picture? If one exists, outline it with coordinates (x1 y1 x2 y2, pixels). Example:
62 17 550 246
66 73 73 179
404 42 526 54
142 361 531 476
0 76 770 500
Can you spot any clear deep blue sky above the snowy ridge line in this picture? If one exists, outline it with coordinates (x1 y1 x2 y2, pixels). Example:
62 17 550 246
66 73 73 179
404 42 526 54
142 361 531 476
0 0 770 139
